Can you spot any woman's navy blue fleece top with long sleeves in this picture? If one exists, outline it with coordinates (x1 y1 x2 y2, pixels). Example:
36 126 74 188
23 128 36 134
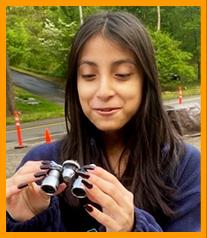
7 142 200 232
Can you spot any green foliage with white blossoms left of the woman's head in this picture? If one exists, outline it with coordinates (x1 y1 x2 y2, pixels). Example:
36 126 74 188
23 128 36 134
7 7 79 77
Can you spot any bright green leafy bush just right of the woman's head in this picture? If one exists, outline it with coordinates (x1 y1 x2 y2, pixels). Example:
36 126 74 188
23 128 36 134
151 31 196 90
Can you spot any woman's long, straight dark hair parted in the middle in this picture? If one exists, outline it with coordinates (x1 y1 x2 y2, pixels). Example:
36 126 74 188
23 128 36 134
60 12 183 217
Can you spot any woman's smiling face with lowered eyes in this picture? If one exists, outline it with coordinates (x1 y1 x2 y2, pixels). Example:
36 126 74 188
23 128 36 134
77 34 143 132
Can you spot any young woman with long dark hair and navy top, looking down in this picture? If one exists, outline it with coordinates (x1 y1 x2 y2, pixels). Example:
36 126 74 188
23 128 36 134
7 12 200 231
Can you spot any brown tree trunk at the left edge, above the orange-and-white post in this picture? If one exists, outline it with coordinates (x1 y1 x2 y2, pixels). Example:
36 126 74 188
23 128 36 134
6 55 15 116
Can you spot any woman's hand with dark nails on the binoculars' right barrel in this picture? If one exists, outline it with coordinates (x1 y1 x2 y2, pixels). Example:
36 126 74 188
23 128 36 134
80 167 134 231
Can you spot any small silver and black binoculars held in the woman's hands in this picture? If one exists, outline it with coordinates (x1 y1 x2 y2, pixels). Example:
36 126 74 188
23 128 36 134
41 160 95 198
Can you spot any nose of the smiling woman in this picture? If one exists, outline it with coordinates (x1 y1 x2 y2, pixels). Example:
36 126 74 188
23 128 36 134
96 76 115 100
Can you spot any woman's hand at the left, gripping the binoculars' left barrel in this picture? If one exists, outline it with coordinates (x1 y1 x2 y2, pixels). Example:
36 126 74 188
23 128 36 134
6 161 65 222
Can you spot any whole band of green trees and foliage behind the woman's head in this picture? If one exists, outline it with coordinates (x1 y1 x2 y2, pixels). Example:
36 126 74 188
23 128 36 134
7 6 200 90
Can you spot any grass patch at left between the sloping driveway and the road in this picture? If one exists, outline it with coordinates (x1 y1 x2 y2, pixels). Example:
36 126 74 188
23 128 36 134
6 87 64 125
